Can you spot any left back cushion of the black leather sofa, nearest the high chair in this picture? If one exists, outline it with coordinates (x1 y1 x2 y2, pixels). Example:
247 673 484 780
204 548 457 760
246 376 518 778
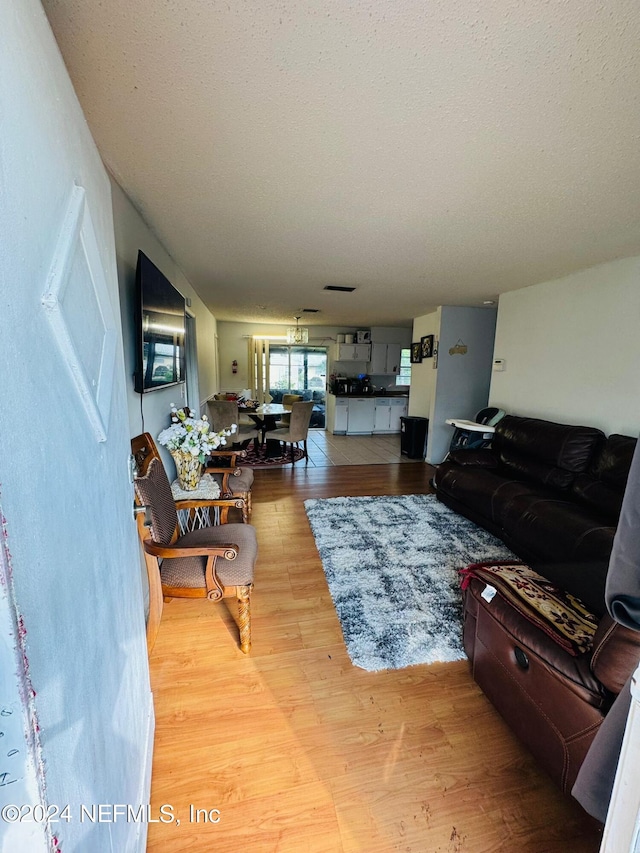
492 415 604 489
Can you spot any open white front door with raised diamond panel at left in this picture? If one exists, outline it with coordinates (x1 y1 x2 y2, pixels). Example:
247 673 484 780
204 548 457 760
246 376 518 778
0 0 152 853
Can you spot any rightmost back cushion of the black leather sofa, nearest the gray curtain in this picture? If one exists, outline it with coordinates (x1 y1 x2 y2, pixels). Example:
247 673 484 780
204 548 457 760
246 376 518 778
572 434 637 519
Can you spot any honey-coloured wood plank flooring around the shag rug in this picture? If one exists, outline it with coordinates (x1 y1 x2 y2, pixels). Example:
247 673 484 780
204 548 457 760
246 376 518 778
148 464 600 853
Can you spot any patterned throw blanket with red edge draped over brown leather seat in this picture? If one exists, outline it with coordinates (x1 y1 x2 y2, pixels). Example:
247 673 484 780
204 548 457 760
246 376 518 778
460 562 598 655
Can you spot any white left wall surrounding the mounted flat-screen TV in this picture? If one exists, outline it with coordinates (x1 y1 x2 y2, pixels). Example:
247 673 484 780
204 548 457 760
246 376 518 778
111 178 217 452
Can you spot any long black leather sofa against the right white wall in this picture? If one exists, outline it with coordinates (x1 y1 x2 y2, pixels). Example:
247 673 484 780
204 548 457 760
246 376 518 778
434 415 636 615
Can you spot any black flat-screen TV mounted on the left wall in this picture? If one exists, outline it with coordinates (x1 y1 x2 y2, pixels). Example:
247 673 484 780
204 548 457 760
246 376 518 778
134 246 186 394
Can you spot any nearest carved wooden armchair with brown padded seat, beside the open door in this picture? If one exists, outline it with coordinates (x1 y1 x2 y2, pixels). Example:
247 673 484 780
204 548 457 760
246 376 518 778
131 433 258 654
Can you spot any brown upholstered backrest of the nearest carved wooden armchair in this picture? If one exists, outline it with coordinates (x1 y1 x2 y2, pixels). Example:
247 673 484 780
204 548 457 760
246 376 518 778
131 432 178 545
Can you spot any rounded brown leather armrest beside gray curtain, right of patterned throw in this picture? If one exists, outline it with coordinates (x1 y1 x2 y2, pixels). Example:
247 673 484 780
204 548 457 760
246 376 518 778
591 613 640 694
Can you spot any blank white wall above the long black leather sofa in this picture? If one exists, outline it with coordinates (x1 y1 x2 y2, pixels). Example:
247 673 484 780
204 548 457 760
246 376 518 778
490 257 640 435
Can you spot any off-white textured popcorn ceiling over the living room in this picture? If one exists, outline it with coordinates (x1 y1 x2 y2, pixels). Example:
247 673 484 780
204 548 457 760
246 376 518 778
43 0 640 325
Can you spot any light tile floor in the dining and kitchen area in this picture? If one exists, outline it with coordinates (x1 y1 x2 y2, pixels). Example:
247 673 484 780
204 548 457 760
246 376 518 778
307 429 423 468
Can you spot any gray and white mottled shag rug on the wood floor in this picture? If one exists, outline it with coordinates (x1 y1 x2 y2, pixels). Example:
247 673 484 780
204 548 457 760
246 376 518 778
304 495 517 672
